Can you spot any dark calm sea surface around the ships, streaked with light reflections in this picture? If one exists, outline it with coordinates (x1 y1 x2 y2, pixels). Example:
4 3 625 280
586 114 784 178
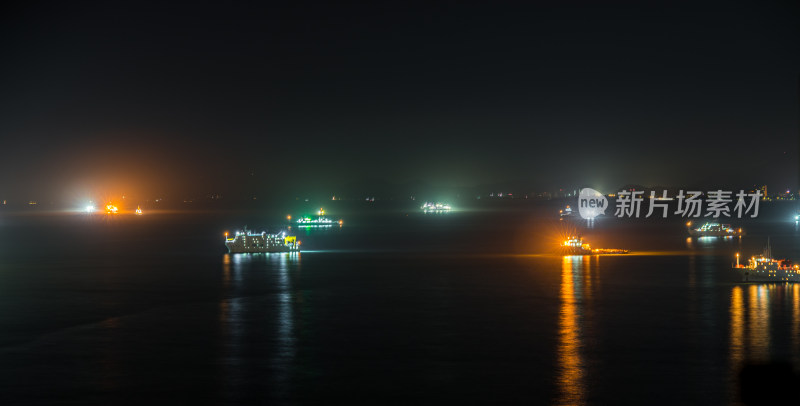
0 203 800 405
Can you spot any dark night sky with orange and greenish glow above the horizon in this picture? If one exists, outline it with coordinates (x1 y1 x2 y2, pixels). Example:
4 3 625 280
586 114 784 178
0 1 800 199
